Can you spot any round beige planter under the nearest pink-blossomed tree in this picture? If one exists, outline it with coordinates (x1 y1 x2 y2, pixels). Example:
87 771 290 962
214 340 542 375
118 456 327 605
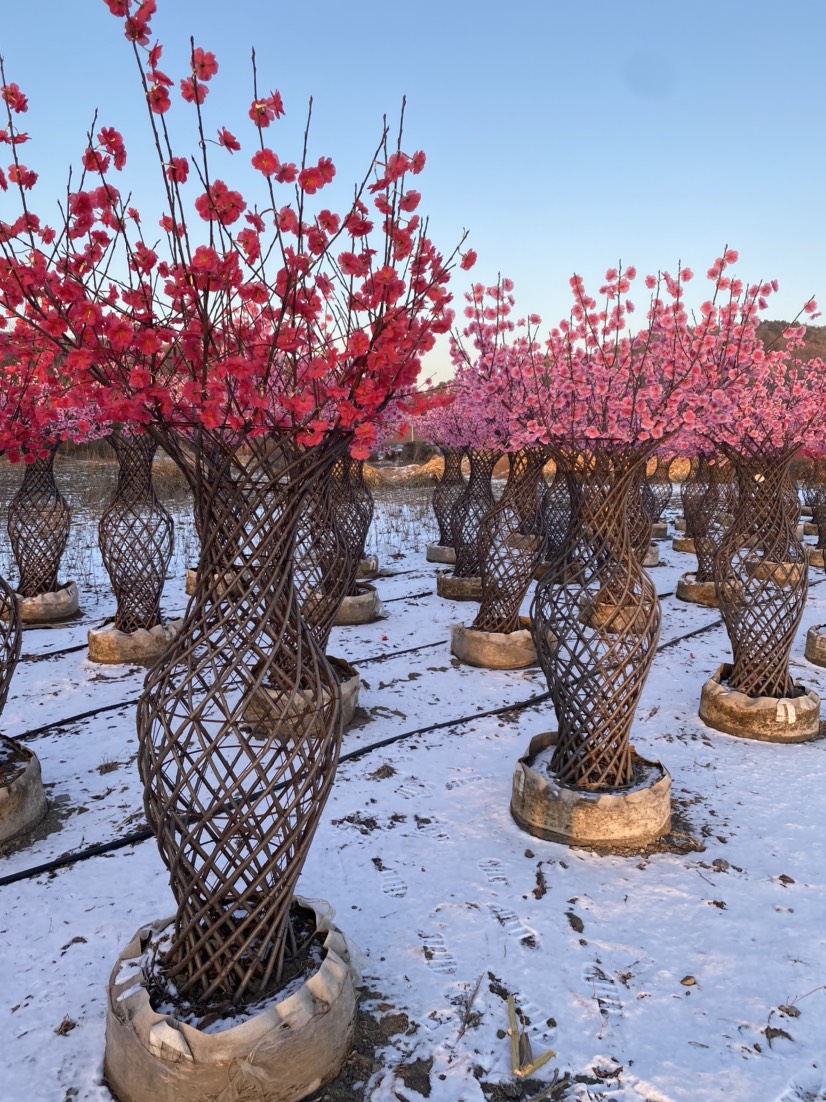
511 732 671 851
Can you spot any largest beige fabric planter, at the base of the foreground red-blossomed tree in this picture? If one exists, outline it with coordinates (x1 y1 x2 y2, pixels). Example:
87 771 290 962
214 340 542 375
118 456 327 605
104 897 360 1102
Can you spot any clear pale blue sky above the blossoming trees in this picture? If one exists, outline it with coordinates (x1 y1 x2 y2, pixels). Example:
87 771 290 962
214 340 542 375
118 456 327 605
0 0 826 374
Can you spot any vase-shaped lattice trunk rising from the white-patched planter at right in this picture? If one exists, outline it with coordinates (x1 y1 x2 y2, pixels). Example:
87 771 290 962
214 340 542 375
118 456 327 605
715 450 808 698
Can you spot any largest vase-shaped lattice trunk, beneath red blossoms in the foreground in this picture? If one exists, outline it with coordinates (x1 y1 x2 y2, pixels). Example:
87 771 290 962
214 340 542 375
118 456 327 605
138 430 341 1007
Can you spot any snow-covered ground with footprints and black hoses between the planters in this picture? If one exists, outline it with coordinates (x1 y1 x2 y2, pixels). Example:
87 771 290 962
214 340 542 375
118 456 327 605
0 484 826 1102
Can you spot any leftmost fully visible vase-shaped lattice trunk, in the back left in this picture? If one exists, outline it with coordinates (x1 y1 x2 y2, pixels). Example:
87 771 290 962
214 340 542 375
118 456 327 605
9 444 72 597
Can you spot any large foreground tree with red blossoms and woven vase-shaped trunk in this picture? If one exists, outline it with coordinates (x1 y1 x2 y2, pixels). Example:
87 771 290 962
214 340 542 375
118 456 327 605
0 0 469 1002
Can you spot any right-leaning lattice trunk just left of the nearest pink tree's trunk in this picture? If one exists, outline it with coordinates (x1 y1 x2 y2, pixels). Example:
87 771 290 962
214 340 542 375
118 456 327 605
472 447 547 635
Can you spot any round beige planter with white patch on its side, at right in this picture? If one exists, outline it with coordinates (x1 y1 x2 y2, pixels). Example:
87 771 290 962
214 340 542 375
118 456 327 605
699 662 820 743
